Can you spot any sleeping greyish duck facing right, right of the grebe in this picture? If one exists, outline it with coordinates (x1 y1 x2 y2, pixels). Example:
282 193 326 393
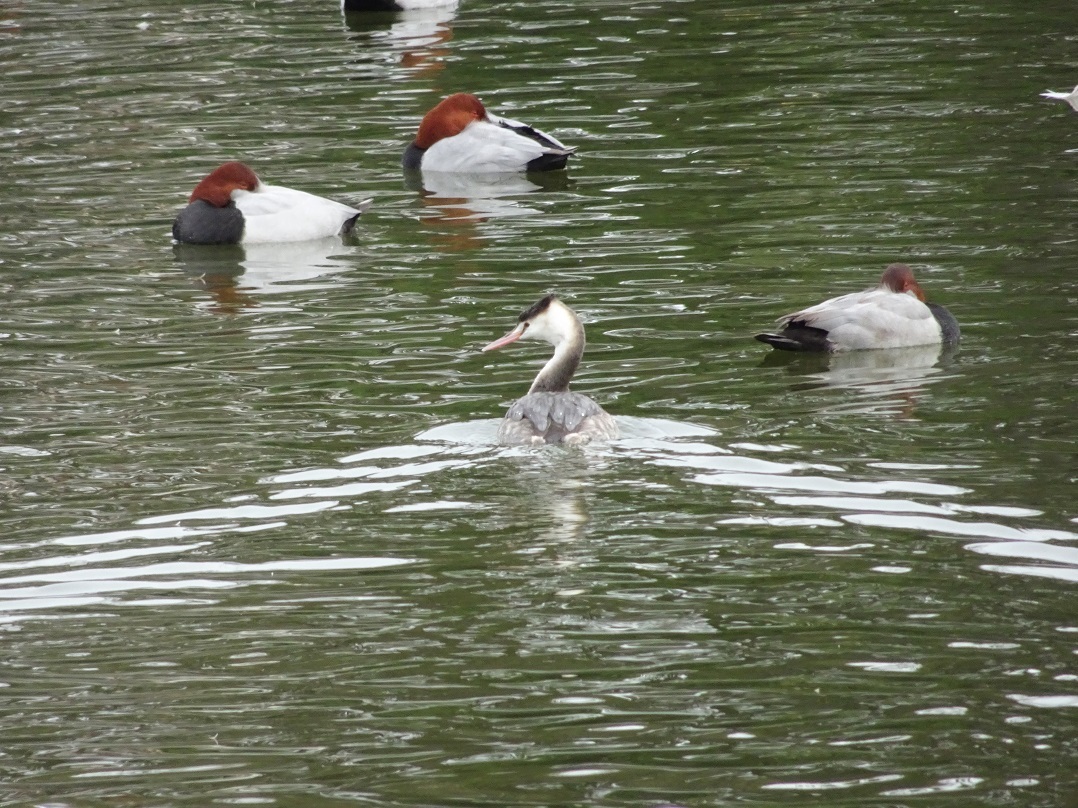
756 264 959 351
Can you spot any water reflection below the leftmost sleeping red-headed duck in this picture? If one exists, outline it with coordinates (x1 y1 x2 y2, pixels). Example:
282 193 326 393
172 238 355 314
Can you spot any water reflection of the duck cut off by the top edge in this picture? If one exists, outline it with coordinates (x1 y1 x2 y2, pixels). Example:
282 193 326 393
341 0 457 76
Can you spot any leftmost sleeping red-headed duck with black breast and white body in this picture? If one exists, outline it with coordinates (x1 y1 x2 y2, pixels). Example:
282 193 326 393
172 163 371 245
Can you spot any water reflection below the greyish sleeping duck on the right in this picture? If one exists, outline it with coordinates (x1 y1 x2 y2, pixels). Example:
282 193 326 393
761 345 957 418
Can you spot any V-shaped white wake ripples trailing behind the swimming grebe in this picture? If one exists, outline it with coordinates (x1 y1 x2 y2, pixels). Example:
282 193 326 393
6 417 1078 612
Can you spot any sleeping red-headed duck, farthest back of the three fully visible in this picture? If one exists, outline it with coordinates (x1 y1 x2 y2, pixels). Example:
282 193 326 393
403 93 576 173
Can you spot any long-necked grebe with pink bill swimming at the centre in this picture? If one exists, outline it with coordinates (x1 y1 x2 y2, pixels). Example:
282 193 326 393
483 294 618 446
